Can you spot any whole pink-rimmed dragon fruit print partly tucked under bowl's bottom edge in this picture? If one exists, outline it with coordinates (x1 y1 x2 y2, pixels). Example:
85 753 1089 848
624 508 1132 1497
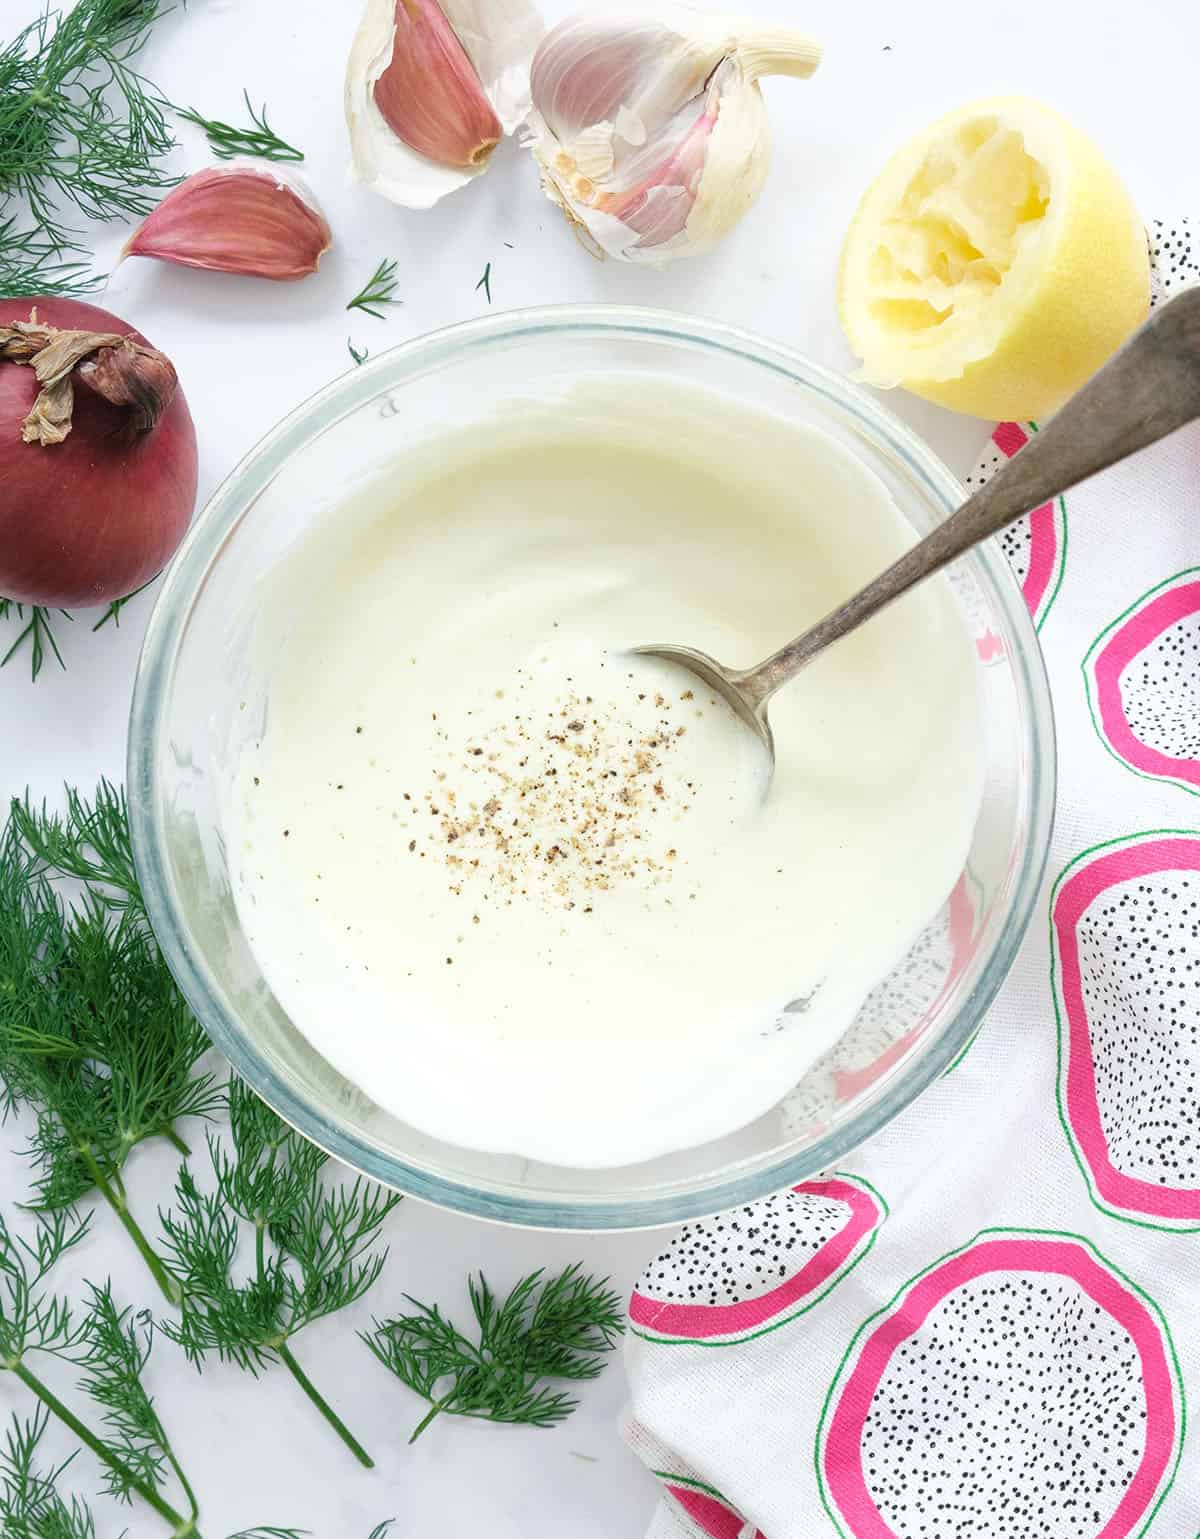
629 1174 888 1347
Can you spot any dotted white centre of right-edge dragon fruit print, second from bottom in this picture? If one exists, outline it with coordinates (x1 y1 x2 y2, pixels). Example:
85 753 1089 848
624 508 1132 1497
1077 871 1200 1187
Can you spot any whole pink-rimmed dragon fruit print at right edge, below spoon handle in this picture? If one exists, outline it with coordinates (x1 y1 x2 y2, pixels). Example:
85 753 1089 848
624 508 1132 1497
1083 566 1200 794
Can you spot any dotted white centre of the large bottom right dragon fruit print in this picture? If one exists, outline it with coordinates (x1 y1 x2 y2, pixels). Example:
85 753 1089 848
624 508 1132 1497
862 1271 1146 1539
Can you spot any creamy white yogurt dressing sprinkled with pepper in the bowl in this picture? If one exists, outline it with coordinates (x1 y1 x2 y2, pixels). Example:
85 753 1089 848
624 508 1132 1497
231 379 980 1167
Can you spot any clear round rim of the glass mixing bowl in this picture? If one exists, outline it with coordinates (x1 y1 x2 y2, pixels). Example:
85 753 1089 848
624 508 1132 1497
128 305 1057 1231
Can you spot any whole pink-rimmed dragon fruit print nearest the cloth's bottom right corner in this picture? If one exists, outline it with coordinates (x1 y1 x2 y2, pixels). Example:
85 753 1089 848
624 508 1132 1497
817 1230 1183 1539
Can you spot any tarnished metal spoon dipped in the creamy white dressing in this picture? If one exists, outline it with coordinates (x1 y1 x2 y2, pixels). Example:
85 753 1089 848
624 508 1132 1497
634 288 1200 770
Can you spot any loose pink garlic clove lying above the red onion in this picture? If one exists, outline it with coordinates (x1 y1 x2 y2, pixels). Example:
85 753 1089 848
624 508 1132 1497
122 160 334 282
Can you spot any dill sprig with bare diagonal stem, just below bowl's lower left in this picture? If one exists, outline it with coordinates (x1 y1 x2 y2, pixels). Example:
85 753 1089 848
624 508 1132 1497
160 1079 400 1468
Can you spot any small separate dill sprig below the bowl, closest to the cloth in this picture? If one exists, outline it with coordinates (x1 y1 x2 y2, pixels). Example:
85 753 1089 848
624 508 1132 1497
360 1264 623 1442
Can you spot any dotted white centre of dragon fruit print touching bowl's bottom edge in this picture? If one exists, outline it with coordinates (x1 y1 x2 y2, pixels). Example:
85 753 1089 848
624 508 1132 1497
638 1191 849 1305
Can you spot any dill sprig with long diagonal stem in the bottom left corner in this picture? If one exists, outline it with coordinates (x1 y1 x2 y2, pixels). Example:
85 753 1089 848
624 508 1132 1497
0 1213 198 1539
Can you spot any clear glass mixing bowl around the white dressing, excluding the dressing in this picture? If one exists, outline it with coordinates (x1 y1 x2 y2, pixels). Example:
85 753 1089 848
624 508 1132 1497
128 306 1055 1230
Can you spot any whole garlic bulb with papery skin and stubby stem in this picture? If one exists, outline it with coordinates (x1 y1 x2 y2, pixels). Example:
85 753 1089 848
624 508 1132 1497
529 5 820 266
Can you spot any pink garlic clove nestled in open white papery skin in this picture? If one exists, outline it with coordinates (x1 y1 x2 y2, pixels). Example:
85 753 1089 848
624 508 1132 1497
372 0 505 169
